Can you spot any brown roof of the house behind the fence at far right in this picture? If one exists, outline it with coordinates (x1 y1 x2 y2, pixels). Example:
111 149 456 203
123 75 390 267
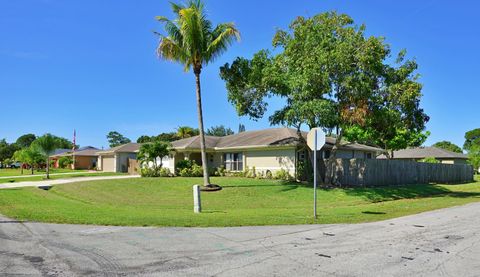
378 146 468 159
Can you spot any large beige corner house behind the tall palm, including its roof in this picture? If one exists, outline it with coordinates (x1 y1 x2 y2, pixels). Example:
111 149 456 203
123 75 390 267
167 128 382 175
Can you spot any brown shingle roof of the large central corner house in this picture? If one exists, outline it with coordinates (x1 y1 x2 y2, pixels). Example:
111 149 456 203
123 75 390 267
172 128 381 151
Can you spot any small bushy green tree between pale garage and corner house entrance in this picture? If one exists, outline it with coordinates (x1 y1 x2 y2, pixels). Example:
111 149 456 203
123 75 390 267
138 141 170 172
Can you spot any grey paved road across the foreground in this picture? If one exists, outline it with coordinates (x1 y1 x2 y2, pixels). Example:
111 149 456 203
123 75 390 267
0 203 480 276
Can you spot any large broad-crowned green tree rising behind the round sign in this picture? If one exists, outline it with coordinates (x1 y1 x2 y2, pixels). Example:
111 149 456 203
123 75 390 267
220 12 428 183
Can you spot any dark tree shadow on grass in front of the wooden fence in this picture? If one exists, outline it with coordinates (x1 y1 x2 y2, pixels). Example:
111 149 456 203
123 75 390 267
344 184 480 203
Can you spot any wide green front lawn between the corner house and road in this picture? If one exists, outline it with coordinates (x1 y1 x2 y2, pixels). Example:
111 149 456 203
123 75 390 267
0 177 480 226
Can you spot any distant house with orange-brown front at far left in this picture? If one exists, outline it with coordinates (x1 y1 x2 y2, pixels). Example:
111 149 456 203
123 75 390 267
50 146 100 169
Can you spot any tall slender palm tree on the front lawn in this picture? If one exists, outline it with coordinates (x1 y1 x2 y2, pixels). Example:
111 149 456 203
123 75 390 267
156 0 240 187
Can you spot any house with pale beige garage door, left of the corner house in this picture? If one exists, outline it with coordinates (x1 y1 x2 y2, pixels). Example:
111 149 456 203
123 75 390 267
97 143 141 172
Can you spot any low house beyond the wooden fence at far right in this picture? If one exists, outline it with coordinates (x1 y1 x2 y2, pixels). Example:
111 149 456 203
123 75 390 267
378 146 468 164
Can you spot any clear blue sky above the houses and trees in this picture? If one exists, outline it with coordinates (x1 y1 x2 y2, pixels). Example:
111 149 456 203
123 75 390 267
0 0 480 147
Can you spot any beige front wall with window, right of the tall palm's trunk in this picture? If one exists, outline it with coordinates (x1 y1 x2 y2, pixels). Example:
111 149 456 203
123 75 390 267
243 148 295 176
